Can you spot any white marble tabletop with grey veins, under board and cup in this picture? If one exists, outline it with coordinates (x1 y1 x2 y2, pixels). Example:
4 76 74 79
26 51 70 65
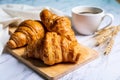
0 0 120 80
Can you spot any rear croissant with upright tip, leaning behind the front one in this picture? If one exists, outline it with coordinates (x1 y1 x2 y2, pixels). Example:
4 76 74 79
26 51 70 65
40 9 76 40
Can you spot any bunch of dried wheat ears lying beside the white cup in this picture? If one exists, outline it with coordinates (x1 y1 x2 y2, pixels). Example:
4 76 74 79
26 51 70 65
94 26 120 54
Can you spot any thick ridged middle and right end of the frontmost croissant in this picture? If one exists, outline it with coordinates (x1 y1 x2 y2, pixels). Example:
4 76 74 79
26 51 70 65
41 32 80 65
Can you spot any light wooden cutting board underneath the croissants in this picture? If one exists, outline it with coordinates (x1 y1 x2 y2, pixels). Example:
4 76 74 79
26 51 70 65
6 26 98 80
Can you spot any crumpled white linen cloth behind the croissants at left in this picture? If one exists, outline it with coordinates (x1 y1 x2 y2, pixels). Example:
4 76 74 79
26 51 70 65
0 4 66 54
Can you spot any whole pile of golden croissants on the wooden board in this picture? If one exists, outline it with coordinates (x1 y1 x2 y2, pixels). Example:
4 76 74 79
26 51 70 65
7 9 85 65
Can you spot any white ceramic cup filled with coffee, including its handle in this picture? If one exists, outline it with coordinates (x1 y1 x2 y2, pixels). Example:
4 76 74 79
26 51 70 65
72 6 114 35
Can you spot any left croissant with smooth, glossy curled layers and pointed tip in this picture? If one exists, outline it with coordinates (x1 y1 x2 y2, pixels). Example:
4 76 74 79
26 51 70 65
7 20 44 48
